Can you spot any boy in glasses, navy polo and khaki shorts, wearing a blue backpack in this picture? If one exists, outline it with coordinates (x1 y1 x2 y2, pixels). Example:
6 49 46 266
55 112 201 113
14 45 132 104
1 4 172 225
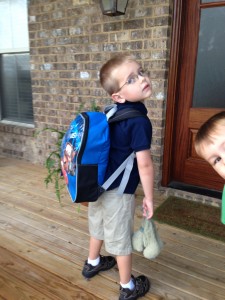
82 55 154 300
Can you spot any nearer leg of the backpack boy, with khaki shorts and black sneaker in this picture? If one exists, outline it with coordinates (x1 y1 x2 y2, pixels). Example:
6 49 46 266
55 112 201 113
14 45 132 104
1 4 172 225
105 194 150 300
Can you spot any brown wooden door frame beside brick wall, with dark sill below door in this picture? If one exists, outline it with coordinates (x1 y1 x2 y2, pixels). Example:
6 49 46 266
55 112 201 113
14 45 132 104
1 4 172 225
161 0 224 198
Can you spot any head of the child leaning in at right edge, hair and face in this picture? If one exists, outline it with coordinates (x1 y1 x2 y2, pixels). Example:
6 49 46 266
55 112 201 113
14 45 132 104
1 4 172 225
195 111 225 179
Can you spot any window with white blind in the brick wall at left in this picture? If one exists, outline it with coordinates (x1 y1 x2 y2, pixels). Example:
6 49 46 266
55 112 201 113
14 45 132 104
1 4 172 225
0 0 33 124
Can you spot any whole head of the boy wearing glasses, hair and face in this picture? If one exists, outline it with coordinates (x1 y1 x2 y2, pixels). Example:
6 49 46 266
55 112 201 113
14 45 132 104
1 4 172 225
100 54 152 103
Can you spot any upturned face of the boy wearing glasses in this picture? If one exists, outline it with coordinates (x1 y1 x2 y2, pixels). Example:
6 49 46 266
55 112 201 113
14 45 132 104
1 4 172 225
112 61 152 103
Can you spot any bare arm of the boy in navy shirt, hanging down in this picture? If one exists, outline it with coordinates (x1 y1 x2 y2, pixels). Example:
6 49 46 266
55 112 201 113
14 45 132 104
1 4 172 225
136 150 154 219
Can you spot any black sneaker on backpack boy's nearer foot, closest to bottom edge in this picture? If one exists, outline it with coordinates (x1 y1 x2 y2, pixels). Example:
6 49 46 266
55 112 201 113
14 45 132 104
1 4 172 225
119 275 151 300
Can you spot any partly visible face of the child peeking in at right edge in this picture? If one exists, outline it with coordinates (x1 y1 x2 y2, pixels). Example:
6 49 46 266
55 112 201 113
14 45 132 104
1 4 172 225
201 125 225 179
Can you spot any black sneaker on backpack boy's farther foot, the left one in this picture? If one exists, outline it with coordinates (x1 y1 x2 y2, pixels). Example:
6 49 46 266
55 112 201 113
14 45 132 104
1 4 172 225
82 255 116 278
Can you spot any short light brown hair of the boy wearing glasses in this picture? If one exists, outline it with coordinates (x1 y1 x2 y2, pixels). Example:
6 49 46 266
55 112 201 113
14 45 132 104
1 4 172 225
100 54 136 96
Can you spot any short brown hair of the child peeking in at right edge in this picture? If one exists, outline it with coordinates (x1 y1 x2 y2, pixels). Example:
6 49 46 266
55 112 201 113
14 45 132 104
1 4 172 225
194 111 225 156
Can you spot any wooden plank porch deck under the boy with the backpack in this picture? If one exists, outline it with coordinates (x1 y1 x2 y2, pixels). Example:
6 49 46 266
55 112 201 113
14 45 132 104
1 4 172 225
0 157 225 300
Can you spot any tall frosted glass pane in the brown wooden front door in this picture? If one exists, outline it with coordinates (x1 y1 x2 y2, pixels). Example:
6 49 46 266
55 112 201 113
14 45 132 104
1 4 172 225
193 7 225 108
